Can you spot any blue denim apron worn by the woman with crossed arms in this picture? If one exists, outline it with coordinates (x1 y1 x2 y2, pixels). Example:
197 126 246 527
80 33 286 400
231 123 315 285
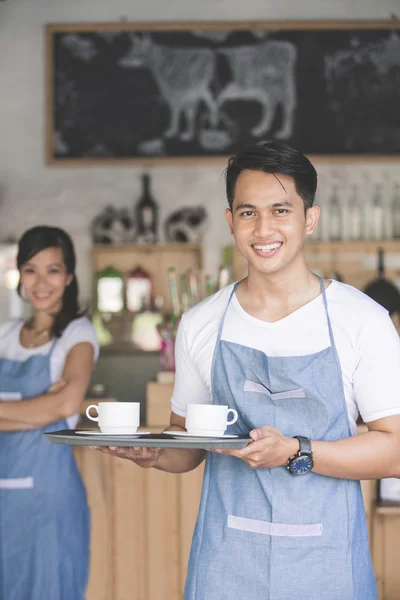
0 328 90 600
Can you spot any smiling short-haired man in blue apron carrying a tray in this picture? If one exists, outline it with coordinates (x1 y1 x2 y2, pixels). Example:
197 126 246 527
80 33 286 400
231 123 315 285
94 143 400 600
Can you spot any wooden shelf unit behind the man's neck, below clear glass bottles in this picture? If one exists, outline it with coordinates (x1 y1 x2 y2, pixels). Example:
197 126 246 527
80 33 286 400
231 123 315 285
226 240 400 290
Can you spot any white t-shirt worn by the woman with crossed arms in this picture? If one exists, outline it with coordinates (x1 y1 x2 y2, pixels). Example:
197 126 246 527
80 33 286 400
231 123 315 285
0 317 99 428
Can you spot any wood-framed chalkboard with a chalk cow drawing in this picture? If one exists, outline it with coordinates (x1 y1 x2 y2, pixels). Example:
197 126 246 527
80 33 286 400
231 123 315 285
46 22 400 164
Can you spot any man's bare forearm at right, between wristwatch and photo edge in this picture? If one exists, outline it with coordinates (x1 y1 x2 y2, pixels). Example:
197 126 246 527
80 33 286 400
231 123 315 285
312 431 400 479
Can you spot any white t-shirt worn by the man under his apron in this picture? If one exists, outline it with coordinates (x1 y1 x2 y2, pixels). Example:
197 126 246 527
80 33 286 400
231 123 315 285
171 281 400 433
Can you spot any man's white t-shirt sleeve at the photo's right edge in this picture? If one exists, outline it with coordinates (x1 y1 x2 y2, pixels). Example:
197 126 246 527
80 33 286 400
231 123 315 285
353 311 400 423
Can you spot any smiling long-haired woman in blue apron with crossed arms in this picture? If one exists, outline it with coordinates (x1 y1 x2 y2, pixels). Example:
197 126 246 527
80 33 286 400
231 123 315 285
0 226 98 600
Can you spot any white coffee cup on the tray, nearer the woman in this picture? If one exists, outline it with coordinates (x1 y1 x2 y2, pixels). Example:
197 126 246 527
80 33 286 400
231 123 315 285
86 402 140 434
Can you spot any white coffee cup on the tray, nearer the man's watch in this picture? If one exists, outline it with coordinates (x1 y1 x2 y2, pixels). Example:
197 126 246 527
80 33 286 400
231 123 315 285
185 404 238 436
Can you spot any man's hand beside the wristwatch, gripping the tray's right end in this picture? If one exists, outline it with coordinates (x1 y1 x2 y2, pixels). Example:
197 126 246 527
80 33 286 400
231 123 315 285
215 425 299 469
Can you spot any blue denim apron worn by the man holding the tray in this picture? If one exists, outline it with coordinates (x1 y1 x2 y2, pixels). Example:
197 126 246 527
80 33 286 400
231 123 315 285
185 280 377 600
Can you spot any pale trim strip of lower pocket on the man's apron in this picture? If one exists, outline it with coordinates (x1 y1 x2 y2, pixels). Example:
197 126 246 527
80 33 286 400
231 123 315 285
228 515 322 537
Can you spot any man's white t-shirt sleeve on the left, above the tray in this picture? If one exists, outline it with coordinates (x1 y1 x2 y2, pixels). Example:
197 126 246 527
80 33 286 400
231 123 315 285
171 316 211 417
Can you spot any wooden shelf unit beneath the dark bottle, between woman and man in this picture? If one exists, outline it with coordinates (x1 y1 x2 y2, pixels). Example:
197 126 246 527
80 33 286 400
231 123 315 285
92 243 202 311
